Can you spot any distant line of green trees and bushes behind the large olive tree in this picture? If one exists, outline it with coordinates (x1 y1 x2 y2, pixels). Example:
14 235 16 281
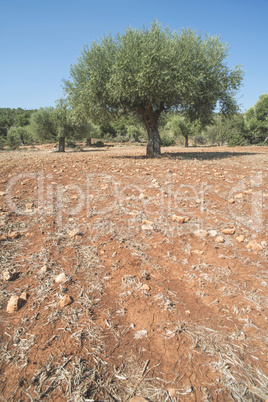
0 94 268 151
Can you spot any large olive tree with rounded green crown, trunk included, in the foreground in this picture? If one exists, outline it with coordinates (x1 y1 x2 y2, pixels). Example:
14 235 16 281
64 22 243 156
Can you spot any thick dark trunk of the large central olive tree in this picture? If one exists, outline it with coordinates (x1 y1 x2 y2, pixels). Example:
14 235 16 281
142 109 161 158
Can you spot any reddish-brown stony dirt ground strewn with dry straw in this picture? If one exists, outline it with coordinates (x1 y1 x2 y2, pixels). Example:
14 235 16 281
0 145 268 402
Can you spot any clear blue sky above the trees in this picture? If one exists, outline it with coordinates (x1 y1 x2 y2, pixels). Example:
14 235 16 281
0 0 268 111
